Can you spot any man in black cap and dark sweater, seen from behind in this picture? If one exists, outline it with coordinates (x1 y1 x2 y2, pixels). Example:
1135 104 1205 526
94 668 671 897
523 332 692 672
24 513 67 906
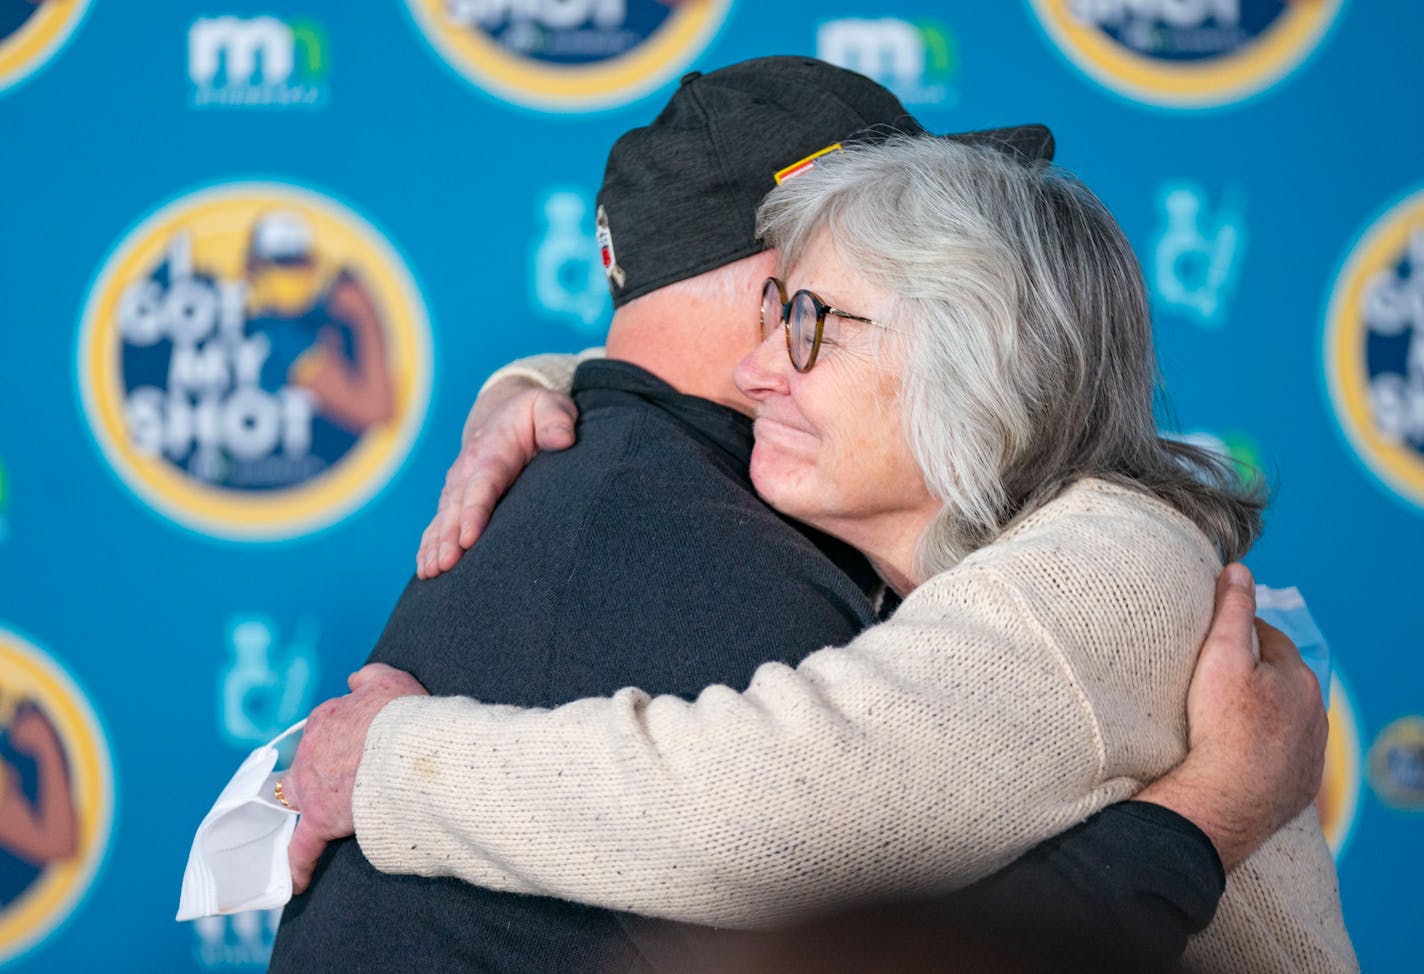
272 58 1327 971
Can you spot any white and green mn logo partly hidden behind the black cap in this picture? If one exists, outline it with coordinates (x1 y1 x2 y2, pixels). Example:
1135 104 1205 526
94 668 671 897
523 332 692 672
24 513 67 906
816 17 960 105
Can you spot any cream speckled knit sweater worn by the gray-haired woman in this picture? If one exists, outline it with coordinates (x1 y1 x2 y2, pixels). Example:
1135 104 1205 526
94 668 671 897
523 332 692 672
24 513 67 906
355 481 1357 974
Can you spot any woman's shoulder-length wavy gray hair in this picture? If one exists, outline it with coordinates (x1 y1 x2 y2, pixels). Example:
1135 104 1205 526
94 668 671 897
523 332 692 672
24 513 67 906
758 135 1265 578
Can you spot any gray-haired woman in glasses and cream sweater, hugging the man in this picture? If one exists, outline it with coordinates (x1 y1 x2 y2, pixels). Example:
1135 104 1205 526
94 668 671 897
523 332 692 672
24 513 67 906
355 137 1356 971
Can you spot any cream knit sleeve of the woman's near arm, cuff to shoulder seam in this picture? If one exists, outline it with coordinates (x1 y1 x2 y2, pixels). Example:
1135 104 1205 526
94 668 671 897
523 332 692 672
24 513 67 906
355 568 1135 927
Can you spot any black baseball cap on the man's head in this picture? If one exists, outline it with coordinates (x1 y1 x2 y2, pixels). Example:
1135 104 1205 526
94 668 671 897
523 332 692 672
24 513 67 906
598 56 1054 308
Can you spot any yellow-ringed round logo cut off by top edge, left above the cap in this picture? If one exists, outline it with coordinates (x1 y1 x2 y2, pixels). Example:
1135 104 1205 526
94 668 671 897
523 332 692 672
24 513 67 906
406 0 732 111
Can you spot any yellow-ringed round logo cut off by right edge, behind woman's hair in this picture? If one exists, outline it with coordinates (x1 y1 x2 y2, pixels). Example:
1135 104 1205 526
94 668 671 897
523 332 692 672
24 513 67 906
1324 191 1424 506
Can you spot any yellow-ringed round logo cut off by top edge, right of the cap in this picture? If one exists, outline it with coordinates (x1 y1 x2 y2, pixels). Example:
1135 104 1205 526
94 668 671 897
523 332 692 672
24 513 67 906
1032 0 1341 108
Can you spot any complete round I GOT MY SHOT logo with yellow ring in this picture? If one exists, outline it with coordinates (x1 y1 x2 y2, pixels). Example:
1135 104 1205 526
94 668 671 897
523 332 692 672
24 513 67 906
78 182 430 541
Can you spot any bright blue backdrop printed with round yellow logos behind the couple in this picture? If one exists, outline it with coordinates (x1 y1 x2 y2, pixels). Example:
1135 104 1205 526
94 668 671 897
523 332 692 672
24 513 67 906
0 0 1424 971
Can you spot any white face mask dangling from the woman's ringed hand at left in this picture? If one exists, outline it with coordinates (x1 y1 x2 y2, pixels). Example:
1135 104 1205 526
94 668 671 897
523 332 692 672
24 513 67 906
178 721 306 920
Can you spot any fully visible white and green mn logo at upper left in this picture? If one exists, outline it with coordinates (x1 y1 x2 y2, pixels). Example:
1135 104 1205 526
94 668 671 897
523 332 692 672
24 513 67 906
188 17 326 107
